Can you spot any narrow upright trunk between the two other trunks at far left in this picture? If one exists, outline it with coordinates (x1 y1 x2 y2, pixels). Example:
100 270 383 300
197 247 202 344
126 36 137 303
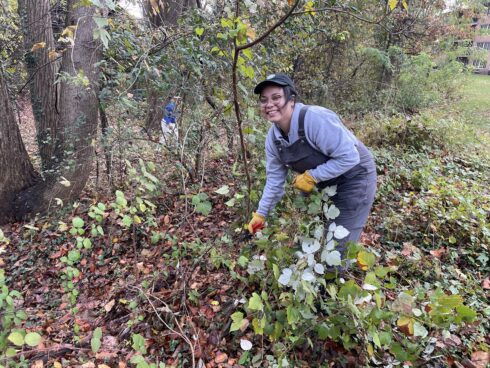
18 0 63 176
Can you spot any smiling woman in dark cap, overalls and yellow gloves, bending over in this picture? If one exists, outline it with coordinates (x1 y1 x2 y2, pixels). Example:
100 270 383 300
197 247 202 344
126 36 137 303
248 73 376 253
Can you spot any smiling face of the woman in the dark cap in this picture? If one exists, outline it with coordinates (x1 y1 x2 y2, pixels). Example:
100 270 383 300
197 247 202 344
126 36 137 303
260 85 294 133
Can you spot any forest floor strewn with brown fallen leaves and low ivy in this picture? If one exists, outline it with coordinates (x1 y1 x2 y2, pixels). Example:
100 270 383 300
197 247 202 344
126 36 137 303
0 77 490 368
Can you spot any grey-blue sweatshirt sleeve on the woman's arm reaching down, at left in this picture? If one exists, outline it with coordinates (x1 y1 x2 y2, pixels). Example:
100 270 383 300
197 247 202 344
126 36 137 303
257 132 288 217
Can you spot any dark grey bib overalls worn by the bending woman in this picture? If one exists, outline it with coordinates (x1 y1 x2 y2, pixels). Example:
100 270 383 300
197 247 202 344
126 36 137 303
274 106 376 254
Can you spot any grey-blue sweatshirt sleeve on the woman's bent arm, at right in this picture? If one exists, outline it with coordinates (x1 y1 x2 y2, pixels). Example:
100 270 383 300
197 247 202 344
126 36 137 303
305 108 360 182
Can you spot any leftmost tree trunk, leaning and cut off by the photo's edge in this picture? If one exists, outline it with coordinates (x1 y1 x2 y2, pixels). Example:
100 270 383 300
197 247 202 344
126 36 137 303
0 70 39 224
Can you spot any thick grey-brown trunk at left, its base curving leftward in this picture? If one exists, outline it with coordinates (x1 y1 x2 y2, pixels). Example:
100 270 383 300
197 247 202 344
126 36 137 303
0 0 101 218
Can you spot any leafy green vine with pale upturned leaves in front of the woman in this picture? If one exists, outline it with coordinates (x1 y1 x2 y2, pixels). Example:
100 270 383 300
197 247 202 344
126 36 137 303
230 187 477 367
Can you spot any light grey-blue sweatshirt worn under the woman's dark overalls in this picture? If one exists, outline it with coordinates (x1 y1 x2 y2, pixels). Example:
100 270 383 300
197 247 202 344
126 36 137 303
257 103 360 217
